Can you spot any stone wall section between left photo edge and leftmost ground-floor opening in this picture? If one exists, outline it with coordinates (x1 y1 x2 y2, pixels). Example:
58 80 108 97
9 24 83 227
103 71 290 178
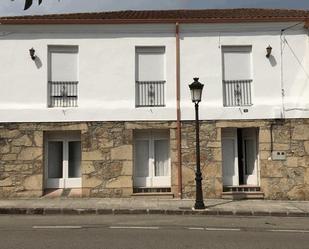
0 124 43 198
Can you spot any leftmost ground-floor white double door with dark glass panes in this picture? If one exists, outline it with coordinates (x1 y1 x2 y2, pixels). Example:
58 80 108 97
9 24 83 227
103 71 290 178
44 133 81 188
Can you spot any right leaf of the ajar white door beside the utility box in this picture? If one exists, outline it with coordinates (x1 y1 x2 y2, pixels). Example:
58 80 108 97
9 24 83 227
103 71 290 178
242 128 258 186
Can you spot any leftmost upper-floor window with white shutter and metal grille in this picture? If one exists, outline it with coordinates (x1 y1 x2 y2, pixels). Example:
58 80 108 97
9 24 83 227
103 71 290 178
48 46 78 107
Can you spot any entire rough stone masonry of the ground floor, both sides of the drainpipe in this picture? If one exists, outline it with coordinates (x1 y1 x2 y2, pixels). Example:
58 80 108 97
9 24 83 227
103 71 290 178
0 119 309 200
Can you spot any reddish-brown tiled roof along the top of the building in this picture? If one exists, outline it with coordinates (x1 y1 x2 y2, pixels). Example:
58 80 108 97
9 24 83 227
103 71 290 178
0 8 309 24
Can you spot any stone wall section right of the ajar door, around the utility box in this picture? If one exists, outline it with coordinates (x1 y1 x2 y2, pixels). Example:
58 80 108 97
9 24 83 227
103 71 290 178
259 119 309 200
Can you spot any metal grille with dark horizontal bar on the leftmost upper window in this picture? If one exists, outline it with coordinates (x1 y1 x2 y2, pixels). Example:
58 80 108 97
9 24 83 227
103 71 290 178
48 81 78 107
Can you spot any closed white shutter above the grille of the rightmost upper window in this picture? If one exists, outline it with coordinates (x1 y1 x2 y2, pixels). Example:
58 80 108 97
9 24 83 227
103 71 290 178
222 46 252 80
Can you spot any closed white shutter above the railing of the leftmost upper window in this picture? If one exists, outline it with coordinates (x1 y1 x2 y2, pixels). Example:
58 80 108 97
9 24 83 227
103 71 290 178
49 46 78 81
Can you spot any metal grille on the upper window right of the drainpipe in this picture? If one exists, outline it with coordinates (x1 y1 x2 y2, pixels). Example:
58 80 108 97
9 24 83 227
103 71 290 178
223 80 252 106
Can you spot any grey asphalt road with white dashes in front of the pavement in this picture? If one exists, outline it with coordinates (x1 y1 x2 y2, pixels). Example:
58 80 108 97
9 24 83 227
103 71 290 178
0 215 309 249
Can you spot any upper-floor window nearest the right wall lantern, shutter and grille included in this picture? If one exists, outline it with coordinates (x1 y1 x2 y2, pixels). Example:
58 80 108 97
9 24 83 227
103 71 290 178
222 46 252 106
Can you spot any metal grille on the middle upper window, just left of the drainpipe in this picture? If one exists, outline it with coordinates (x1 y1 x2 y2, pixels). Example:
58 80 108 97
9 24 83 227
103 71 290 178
136 81 165 107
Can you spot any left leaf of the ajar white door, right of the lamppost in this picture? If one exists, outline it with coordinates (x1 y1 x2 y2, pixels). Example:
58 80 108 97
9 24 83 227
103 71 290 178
222 128 239 186
